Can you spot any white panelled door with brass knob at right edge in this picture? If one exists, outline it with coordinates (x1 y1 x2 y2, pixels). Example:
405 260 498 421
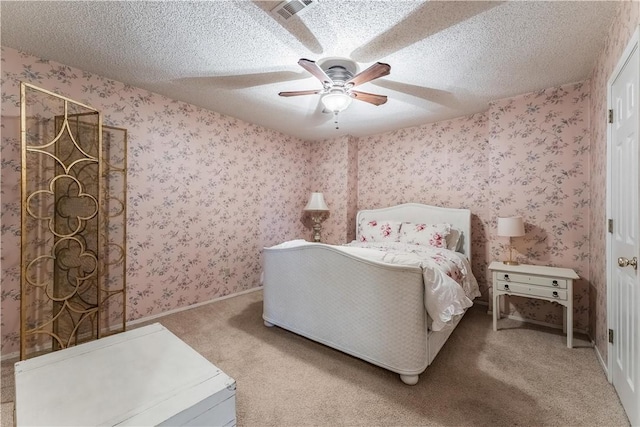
608 27 640 426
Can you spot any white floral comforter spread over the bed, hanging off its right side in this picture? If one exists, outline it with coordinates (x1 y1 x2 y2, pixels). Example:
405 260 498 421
274 240 480 331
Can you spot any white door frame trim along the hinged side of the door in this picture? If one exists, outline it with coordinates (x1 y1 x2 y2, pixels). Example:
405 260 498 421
605 26 640 383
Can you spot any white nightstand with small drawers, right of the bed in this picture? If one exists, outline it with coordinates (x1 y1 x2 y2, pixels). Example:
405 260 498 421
489 261 580 348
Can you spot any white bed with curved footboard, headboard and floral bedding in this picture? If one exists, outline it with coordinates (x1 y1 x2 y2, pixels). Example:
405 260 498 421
263 203 480 385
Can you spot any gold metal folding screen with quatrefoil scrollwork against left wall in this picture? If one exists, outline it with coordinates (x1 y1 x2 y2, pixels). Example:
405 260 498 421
20 83 126 359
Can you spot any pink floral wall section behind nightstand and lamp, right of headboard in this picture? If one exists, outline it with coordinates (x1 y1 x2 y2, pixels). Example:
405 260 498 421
488 82 590 330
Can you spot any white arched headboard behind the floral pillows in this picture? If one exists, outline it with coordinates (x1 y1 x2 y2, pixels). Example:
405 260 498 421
356 203 471 261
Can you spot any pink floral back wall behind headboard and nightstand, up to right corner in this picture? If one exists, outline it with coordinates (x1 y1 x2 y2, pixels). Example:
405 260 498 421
358 83 589 330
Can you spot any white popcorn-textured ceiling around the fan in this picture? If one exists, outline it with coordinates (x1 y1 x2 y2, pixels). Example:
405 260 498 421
0 0 616 139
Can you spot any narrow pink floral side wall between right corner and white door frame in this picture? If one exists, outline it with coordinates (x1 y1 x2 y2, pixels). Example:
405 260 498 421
589 1 640 362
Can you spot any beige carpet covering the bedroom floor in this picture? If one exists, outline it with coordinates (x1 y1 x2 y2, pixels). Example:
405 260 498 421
1 292 629 427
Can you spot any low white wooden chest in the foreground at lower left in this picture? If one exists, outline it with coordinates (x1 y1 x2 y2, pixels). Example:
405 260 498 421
15 323 236 426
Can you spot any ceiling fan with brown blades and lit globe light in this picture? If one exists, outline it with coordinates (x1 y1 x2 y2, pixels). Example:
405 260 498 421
279 58 391 114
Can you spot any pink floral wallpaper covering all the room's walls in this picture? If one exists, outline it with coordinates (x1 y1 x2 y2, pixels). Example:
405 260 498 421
1 2 639 364
